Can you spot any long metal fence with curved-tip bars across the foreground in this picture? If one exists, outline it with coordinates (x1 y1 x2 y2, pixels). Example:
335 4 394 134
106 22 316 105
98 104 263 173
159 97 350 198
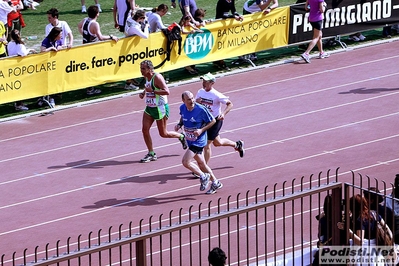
1 169 396 266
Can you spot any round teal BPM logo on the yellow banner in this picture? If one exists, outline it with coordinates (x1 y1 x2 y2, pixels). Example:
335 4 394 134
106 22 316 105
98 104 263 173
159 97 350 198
184 29 214 60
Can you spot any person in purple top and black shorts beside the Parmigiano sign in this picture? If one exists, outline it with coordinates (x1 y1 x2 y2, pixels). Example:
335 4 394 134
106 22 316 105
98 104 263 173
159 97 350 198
301 0 330 63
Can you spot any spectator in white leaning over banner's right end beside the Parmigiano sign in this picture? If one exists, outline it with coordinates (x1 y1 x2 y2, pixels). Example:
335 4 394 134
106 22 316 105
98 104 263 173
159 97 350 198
232 0 278 65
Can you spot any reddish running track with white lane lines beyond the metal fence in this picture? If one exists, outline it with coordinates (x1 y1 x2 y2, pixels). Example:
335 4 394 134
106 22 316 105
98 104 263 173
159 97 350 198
0 42 399 264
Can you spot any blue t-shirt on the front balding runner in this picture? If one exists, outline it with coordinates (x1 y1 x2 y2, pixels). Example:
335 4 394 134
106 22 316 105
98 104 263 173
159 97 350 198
180 103 213 147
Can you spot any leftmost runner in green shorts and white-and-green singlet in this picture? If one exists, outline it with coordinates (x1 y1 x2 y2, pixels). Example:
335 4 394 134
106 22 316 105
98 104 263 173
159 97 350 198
139 60 187 163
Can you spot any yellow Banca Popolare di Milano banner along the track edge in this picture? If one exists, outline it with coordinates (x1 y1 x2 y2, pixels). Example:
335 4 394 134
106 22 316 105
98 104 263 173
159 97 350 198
0 7 289 104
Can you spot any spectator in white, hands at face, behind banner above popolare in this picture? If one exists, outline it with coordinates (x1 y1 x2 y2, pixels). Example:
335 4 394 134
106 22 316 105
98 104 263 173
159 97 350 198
125 10 149 90
